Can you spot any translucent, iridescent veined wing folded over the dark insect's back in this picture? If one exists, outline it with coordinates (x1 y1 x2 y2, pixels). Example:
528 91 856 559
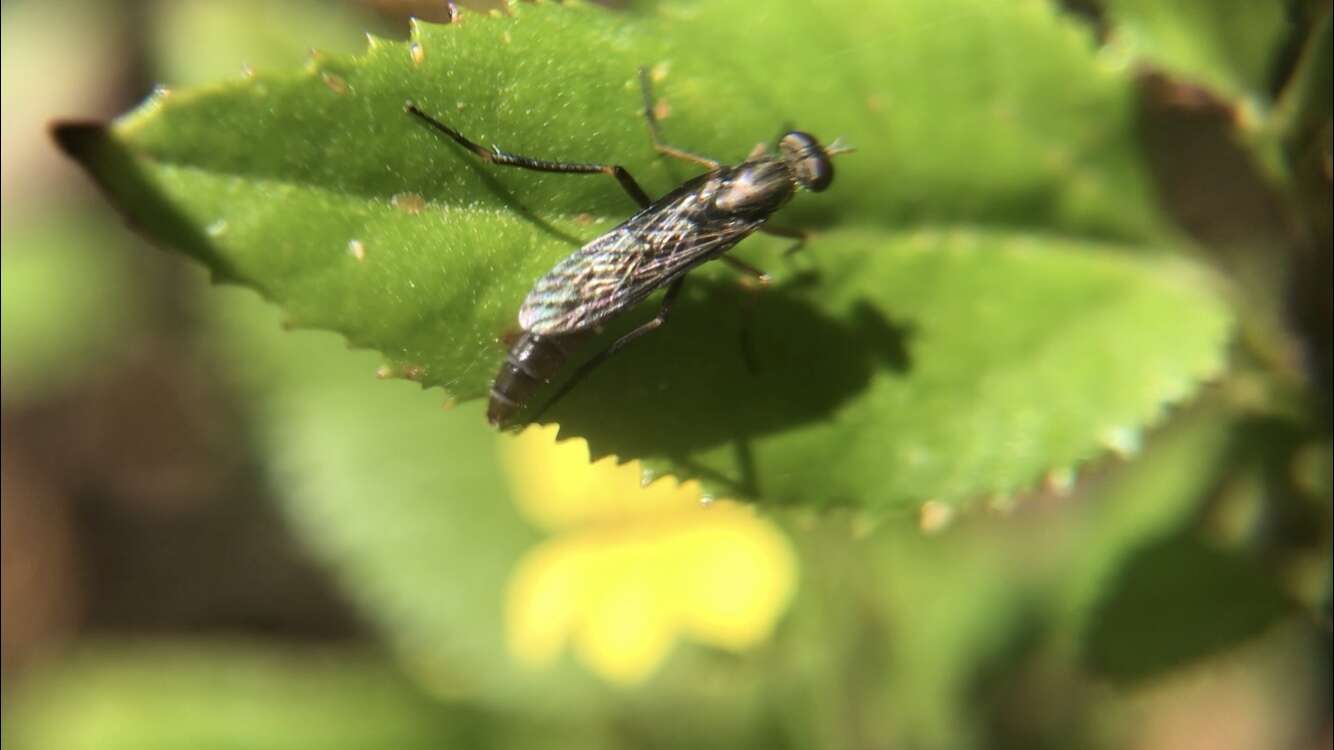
519 185 763 335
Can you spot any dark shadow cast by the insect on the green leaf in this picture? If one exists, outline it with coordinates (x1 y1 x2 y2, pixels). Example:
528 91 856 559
547 274 914 496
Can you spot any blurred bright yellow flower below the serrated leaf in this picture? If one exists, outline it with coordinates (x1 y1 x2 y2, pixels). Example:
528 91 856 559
506 427 796 685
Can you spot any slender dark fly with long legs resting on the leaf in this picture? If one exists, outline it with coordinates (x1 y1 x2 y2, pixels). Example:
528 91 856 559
404 68 851 428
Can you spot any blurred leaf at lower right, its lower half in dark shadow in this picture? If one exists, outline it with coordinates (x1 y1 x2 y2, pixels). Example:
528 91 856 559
1058 405 1289 679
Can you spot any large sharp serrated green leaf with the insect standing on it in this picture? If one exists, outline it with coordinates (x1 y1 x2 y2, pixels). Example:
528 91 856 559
57 0 1227 508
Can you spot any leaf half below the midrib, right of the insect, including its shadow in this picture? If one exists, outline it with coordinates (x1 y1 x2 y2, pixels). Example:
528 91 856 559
552 231 1227 508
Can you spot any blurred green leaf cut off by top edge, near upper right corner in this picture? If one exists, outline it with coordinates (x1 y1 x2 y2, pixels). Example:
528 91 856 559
1106 0 1290 107
